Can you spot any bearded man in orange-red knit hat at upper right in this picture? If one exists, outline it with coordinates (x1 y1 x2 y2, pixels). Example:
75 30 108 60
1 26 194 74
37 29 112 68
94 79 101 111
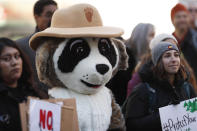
171 3 197 78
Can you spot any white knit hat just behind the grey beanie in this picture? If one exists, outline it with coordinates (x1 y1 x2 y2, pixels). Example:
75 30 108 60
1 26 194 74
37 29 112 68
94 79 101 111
149 33 178 50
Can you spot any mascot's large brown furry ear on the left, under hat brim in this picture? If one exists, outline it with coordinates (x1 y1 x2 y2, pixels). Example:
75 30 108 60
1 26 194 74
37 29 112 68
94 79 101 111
36 37 65 87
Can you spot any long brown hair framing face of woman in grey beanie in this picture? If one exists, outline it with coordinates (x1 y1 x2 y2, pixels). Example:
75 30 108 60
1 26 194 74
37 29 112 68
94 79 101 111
152 57 187 81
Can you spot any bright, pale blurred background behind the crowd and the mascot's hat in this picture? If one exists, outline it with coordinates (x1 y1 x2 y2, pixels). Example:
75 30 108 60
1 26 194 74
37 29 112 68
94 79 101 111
0 0 178 40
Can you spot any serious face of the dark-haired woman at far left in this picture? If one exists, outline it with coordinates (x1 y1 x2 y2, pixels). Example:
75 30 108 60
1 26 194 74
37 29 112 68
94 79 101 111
0 46 23 84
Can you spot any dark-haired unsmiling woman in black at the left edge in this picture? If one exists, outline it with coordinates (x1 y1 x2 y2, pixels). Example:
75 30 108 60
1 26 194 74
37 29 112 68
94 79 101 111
0 38 47 131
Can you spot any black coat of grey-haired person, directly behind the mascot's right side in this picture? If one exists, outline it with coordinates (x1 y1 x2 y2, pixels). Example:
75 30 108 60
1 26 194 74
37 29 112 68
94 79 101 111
106 48 136 105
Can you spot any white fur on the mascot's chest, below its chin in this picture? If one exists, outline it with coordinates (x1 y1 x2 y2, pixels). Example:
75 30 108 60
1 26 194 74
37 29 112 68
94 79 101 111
49 87 112 131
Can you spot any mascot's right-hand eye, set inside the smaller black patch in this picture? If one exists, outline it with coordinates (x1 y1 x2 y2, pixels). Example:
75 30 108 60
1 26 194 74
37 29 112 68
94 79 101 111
99 38 110 53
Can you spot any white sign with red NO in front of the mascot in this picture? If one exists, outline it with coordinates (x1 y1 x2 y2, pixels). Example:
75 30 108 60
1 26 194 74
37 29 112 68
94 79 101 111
29 99 61 131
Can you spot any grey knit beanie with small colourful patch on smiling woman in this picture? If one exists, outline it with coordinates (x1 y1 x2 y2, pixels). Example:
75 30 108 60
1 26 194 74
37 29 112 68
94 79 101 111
151 42 179 65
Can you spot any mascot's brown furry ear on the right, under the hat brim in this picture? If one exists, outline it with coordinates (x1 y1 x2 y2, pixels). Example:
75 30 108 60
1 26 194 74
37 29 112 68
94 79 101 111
112 38 128 75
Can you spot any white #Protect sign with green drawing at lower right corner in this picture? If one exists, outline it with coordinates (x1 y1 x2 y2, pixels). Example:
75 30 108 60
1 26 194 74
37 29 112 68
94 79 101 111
159 98 197 131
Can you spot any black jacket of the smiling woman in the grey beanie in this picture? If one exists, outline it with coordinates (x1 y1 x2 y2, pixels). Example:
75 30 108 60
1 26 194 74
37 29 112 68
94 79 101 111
124 61 196 131
